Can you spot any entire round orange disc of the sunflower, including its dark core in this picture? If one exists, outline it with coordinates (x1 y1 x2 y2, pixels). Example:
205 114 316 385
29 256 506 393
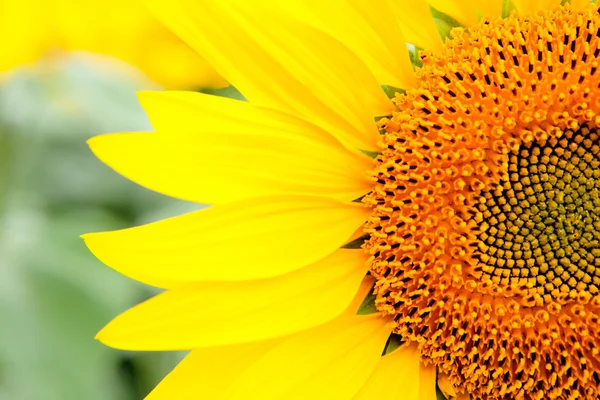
363 3 600 400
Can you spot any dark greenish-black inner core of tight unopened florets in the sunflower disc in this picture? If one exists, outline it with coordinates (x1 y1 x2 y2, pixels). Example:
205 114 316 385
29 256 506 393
474 125 600 305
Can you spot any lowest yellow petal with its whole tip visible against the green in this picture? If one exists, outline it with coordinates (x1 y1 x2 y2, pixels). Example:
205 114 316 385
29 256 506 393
97 249 367 350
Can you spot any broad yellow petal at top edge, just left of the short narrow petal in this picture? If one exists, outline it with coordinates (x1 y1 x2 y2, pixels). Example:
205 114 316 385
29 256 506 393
271 0 416 89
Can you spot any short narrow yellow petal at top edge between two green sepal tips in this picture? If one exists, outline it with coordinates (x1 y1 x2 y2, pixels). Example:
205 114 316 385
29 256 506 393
388 0 443 51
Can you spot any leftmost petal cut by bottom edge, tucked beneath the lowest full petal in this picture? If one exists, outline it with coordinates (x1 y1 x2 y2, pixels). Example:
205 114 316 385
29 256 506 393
145 341 277 400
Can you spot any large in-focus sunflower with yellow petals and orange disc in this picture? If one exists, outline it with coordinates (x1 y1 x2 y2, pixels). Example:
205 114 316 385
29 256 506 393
84 0 600 400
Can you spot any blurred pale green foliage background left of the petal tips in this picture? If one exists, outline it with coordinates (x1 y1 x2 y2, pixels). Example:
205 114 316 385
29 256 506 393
0 54 206 400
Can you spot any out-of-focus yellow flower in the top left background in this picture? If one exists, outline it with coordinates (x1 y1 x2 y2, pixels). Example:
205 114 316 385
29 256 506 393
0 0 226 89
